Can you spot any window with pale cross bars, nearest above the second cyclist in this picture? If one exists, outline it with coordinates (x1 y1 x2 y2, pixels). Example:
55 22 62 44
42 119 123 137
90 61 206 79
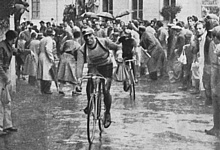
132 0 143 19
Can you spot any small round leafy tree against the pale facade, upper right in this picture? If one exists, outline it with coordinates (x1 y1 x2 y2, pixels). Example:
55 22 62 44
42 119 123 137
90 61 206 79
160 5 182 21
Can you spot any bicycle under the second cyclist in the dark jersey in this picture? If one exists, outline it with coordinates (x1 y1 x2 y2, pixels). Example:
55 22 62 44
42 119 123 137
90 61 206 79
124 59 136 100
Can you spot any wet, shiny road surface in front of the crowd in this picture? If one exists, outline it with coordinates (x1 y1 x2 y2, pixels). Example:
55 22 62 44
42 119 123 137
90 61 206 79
0 77 220 150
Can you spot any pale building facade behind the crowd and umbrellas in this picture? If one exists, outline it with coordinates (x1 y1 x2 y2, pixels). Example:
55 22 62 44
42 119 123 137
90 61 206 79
22 0 220 24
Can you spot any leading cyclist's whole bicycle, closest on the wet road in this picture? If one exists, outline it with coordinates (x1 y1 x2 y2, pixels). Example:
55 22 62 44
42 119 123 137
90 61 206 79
82 74 107 144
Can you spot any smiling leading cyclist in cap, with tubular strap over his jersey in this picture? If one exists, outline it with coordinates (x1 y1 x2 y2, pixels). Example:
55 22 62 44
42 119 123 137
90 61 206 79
76 27 123 128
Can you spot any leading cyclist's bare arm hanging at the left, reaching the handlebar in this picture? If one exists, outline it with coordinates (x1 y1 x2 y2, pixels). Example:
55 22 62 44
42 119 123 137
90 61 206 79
76 46 85 79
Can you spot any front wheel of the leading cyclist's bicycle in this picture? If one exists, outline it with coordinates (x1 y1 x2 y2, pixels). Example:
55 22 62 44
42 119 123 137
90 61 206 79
87 94 96 144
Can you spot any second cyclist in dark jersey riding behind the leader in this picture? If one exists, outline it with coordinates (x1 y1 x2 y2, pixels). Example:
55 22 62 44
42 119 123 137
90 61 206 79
118 29 137 91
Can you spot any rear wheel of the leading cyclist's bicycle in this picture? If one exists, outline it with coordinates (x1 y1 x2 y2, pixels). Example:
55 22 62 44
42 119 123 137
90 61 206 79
97 82 104 132
